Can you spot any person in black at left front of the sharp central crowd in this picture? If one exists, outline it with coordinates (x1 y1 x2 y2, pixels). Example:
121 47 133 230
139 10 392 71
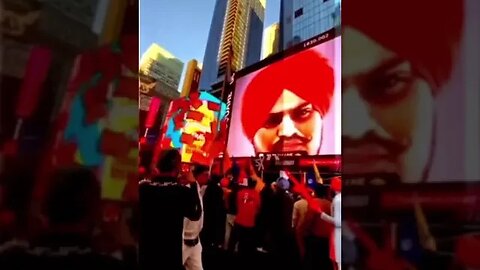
139 150 202 270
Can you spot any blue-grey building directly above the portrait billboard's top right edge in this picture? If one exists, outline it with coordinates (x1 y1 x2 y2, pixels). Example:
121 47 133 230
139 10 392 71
280 0 341 49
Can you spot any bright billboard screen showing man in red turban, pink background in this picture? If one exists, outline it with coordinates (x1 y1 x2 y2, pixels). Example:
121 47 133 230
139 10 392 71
227 36 341 157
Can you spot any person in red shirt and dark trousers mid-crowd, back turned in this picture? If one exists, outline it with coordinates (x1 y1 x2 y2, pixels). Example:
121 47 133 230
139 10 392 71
228 177 261 257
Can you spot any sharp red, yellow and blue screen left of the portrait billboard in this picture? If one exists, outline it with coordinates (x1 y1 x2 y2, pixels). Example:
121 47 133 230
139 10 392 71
161 92 227 165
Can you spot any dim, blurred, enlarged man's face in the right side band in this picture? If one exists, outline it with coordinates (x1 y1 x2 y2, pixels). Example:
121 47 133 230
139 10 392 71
342 27 434 182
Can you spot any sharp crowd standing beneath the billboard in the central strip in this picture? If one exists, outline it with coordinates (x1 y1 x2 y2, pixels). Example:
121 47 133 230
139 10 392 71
139 150 340 270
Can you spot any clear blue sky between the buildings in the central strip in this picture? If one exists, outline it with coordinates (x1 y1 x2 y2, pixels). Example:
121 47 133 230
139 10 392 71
139 0 281 91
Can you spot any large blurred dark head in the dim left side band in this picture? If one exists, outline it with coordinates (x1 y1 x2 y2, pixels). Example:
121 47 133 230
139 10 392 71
43 167 101 224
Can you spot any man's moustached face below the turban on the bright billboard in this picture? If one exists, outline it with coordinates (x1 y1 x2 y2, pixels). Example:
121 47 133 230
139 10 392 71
253 89 323 155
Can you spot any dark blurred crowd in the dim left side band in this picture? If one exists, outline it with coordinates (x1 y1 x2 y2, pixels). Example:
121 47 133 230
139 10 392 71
0 161 137 270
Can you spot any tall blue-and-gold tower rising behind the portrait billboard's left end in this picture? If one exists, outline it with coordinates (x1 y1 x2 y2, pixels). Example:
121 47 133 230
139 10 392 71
200 0 266 90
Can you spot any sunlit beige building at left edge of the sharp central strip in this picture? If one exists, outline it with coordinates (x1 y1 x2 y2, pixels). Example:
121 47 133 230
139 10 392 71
140 43 183 124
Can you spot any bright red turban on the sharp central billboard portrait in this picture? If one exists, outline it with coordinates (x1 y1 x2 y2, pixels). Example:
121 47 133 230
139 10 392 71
241 49 334 139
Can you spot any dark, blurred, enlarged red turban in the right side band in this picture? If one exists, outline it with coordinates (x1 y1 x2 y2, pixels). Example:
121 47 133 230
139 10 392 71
342 0 464 88
